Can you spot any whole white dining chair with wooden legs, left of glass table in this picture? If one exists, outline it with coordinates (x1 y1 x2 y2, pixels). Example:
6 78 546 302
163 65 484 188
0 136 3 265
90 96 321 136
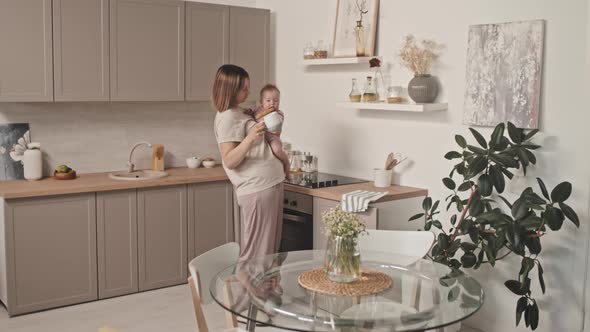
188 242 246 332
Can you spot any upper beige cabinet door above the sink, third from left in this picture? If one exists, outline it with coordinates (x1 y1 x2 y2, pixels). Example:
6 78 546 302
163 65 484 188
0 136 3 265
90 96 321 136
110 0 185 101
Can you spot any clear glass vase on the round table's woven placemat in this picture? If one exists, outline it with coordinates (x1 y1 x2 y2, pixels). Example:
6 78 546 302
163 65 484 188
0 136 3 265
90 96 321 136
324 236 361 282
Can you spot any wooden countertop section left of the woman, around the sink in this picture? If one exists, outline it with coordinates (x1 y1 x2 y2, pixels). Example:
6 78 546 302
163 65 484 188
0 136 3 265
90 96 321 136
0 166 228 199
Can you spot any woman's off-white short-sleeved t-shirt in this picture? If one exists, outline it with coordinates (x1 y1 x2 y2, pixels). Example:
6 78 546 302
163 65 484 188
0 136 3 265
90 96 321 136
214 107 285 196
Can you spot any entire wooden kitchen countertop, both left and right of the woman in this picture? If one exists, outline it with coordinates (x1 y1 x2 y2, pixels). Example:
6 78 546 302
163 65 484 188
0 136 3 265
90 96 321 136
0 166 428 203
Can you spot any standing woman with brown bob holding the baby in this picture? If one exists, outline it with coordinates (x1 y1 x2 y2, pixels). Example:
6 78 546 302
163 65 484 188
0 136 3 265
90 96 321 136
213 65 285 262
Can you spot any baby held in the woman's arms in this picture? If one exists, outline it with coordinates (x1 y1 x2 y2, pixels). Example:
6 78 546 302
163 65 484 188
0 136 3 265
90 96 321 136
252 84 291 178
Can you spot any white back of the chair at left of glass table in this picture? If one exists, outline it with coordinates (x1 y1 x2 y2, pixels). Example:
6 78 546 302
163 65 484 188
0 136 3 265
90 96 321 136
188 242 240 303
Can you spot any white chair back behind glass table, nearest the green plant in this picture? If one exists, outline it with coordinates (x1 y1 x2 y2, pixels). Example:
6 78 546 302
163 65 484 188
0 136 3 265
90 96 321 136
359 229 434 258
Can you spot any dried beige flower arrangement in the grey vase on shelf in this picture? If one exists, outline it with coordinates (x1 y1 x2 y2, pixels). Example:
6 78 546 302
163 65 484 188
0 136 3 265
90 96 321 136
398 34 443 75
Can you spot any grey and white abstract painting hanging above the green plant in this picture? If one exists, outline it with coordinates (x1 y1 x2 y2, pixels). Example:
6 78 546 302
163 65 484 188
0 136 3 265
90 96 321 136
463 20 545 129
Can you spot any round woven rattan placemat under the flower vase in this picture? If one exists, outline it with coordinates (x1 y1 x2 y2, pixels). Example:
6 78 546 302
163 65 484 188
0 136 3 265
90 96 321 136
297 269 393 296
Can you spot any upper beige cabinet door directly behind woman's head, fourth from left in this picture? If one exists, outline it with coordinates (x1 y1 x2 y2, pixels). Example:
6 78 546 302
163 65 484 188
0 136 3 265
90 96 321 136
185 2 229 101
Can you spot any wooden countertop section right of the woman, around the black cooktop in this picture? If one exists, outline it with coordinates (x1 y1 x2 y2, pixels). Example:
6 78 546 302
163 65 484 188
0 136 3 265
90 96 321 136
285 182 428 203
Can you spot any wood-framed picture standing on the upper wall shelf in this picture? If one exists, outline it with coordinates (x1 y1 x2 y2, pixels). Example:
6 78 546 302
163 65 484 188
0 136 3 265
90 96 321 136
332 0 379 57
